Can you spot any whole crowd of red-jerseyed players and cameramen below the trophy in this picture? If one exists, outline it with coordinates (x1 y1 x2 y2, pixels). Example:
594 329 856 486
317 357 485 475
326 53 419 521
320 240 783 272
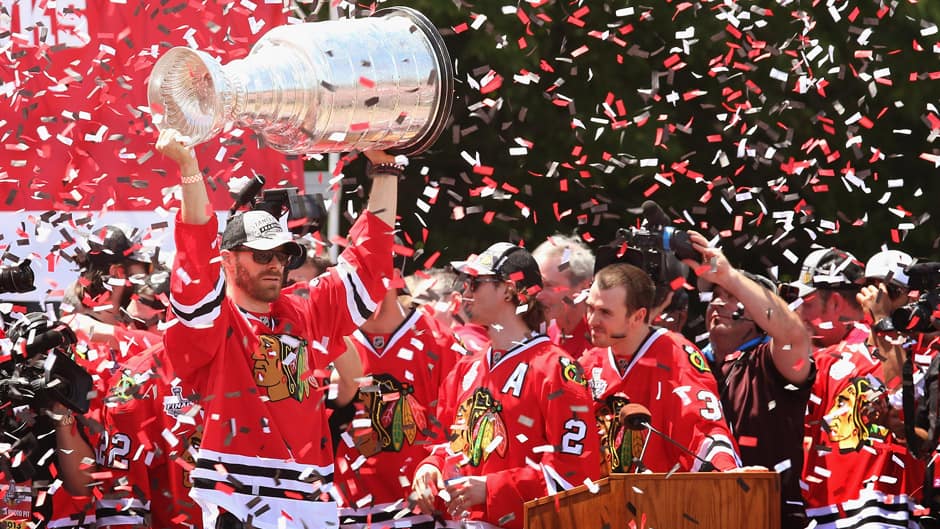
0 130 940 529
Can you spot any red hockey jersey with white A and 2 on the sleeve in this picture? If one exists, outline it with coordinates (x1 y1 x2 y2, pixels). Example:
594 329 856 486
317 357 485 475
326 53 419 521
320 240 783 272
418 335 600 528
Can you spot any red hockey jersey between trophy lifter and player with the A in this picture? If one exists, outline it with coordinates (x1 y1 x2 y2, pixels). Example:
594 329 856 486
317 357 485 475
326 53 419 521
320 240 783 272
336 311 459 525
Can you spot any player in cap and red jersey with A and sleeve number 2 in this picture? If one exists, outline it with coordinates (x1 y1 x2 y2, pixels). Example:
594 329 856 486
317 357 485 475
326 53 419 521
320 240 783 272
413 243 598 529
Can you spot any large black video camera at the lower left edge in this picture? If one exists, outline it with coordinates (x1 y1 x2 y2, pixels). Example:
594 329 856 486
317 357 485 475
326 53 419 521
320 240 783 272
0 312 93 482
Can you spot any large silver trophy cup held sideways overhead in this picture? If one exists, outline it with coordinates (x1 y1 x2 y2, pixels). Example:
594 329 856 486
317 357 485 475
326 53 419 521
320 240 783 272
147 7 454 154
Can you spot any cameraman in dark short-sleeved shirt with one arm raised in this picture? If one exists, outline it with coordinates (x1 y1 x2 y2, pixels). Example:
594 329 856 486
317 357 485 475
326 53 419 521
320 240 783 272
686 232 816 529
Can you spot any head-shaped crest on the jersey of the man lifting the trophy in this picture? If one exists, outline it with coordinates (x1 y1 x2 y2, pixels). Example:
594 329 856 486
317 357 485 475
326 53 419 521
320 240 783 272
251 334 312 402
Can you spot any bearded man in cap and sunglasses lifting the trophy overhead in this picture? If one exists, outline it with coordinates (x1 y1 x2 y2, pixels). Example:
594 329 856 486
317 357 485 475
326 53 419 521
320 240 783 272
157 130 404 529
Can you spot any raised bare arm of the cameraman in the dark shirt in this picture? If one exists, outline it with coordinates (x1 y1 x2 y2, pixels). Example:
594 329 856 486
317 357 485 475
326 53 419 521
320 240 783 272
685 232 812 384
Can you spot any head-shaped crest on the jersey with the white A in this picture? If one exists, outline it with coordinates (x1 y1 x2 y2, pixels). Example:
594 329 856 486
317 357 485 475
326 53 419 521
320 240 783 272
450 388 509 467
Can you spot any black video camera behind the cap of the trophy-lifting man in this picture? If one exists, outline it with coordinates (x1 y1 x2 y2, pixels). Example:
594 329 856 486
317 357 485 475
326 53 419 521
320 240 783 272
229 175 326 237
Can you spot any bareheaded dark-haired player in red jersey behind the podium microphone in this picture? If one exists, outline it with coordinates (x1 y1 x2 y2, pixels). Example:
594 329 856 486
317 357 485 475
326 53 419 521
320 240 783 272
580 263 740 472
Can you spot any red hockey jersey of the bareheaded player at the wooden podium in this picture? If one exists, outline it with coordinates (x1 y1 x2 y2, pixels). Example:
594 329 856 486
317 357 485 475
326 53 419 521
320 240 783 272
580 328 741 472
